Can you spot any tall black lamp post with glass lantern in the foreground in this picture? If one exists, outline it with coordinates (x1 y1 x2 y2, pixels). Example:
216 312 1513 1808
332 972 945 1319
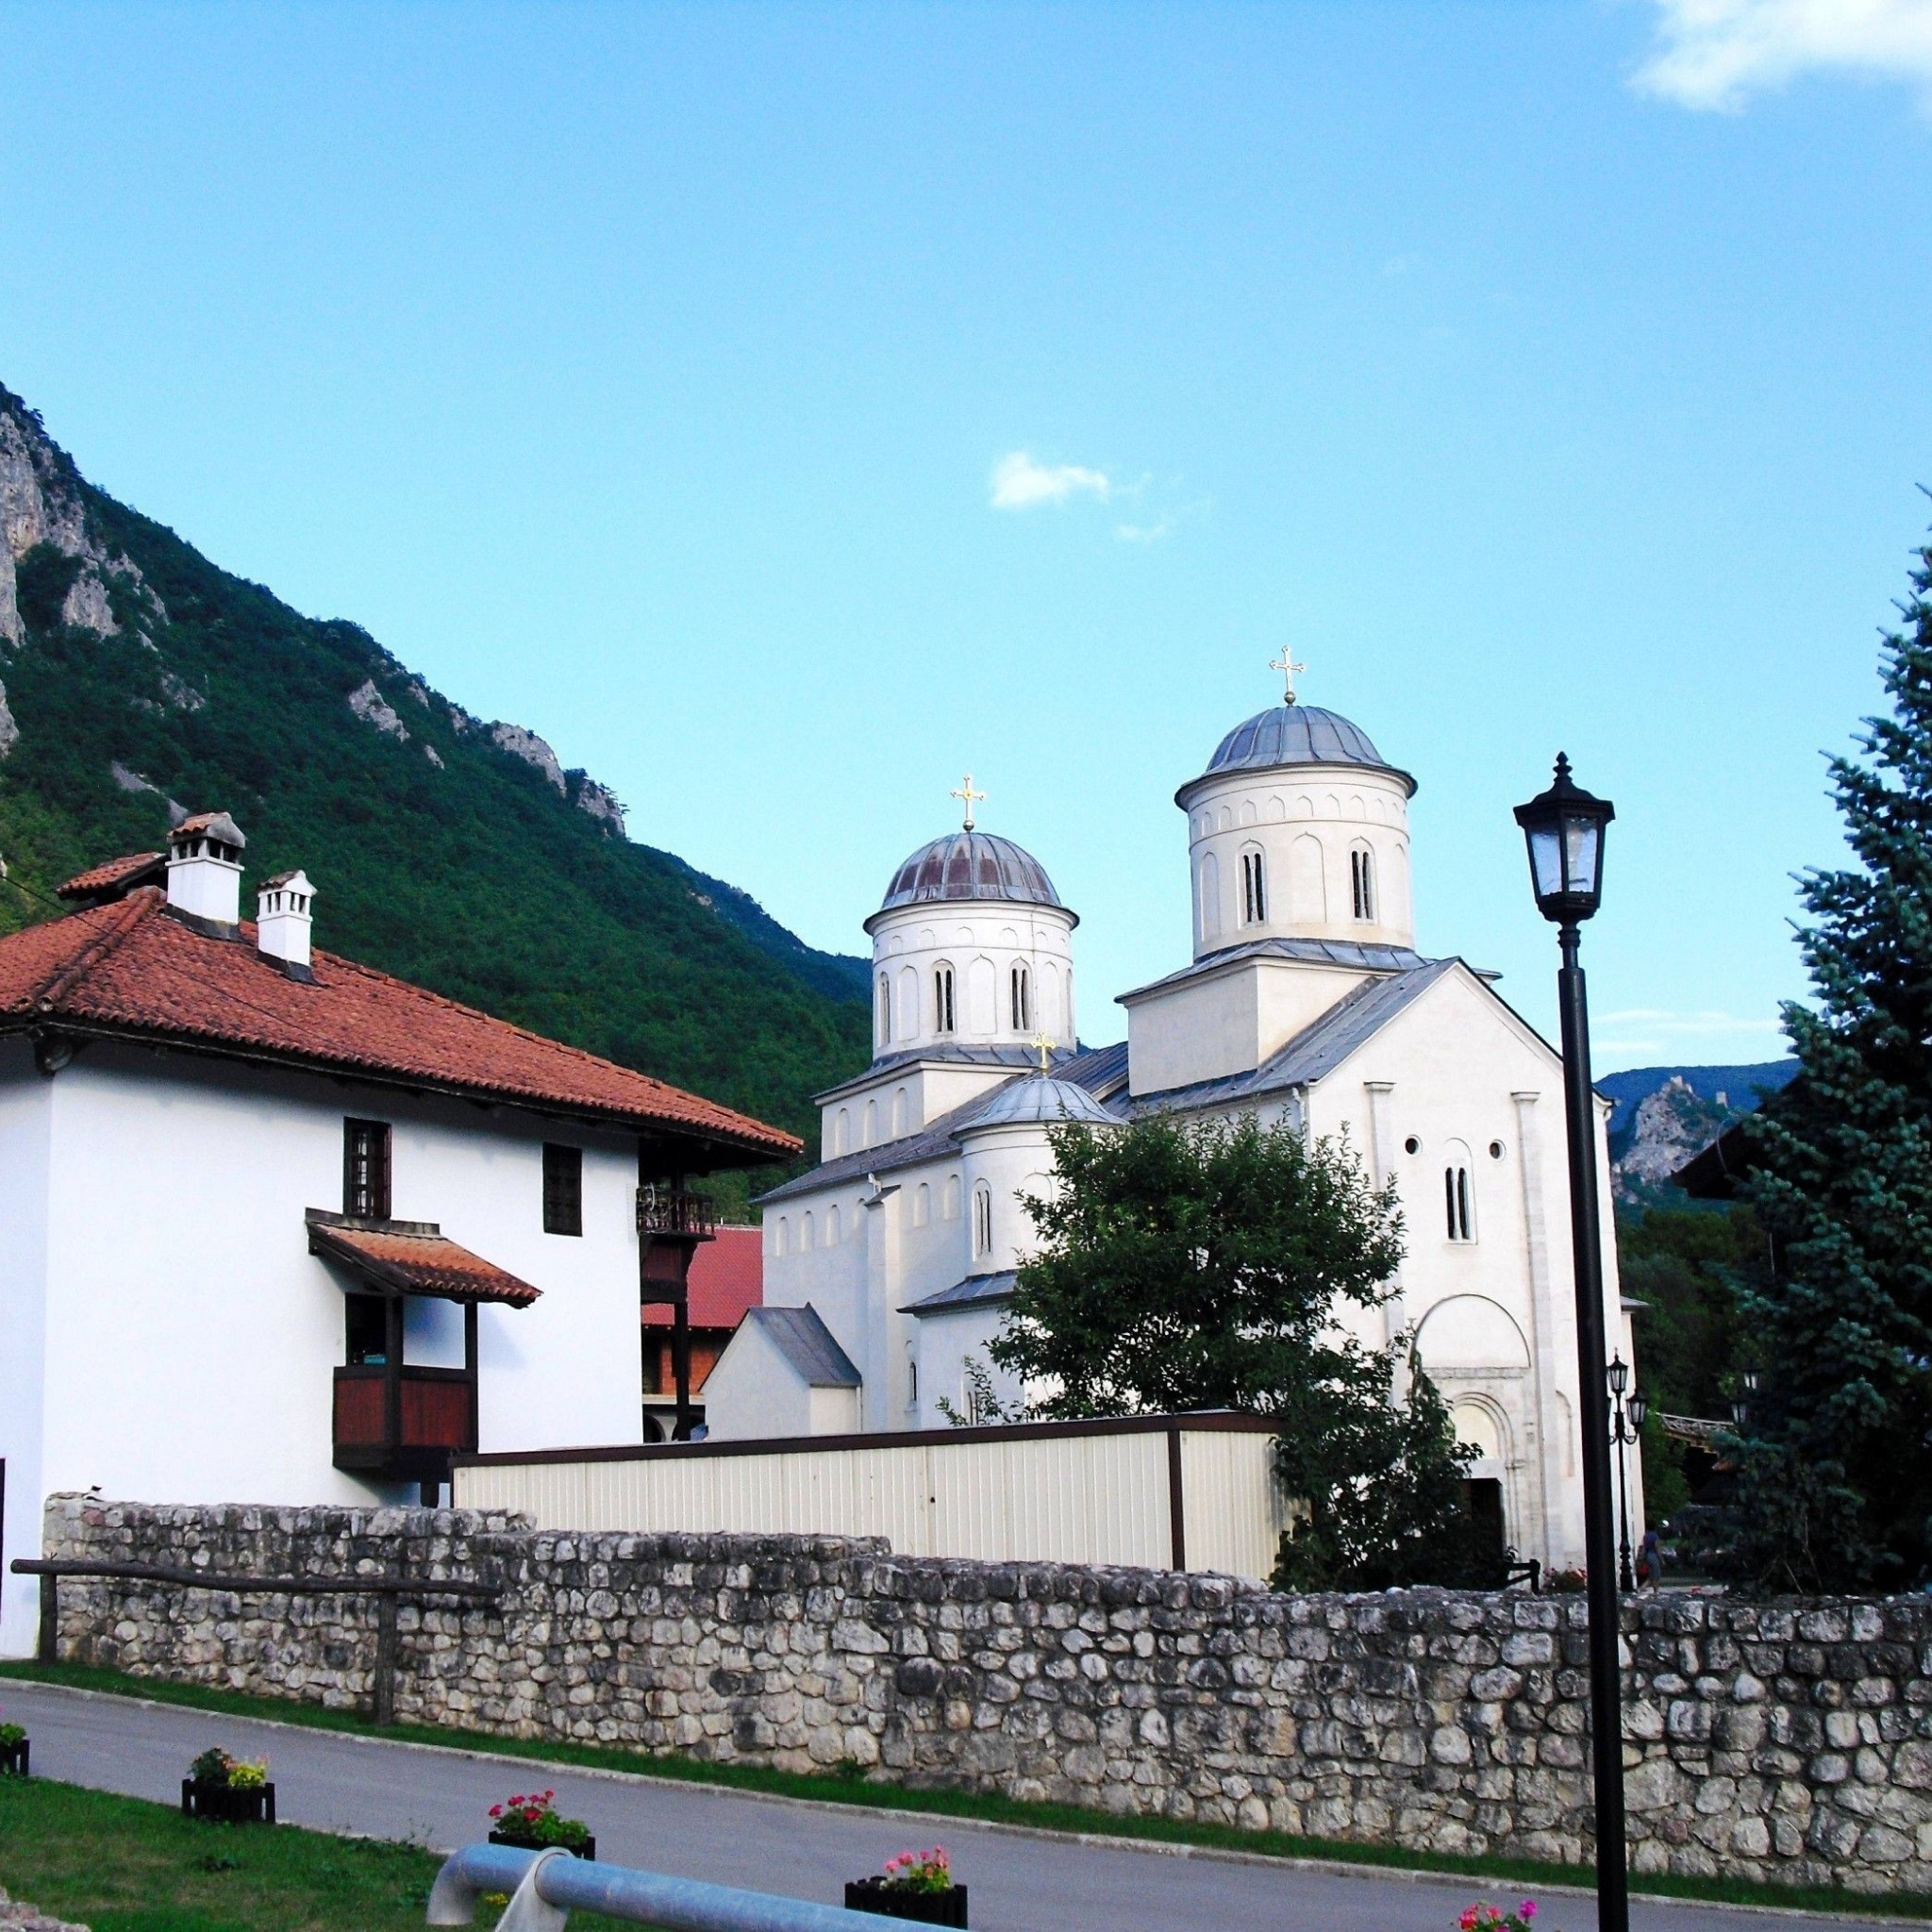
1517 756 1631 1932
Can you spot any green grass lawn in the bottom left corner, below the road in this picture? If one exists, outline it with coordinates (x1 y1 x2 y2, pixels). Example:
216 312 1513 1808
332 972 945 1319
0 1777 636 1932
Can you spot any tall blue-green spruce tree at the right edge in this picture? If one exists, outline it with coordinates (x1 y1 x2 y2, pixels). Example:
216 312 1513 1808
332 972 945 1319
1733 549 1932 1591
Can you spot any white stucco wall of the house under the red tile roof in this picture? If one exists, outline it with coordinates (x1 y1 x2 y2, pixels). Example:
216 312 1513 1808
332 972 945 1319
0 1045 641 1652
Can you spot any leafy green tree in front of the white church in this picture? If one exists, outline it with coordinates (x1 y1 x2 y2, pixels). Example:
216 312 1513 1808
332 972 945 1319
991 1115 1468 1588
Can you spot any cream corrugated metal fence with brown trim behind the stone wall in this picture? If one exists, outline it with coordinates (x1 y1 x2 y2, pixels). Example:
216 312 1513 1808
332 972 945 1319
454 1412 1287 1578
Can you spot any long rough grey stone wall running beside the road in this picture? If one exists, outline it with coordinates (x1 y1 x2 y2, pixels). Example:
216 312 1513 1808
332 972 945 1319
46 1495 1932 1891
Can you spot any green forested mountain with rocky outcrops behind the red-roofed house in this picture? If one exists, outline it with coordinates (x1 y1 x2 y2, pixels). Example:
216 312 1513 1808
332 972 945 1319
0 389 870 1190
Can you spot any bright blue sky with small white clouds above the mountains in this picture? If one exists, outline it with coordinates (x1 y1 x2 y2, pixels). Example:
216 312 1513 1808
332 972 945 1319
0 0 1932 1073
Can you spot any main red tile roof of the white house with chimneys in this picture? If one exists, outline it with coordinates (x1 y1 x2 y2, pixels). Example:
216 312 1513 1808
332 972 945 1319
0 885 800 1165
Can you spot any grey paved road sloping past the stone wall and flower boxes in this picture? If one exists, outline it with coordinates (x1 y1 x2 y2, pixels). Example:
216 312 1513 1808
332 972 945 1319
0 1681 1916 1932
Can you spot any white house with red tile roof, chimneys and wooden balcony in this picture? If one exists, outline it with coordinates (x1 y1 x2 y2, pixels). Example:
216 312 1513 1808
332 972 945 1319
0 813 798 1654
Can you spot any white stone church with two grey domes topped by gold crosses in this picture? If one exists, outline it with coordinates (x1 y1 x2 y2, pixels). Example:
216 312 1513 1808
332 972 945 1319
706 667 1642 1567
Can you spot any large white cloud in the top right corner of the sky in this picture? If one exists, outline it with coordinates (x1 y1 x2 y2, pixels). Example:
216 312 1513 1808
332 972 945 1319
1637 0 1932 114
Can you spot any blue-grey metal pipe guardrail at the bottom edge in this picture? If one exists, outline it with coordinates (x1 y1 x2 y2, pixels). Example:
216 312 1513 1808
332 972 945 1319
429 1845 879 1932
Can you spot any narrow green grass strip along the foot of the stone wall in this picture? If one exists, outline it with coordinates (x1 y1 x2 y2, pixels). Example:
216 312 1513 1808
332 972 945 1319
0 1663 1932 1921
